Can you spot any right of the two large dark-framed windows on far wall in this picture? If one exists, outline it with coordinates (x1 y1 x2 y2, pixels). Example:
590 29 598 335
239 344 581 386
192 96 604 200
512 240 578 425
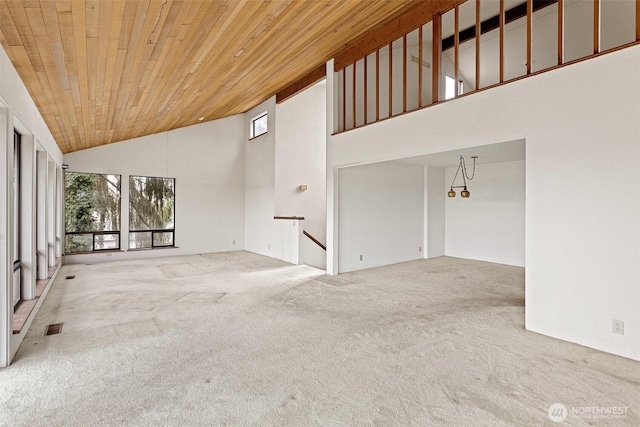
129 176 175 249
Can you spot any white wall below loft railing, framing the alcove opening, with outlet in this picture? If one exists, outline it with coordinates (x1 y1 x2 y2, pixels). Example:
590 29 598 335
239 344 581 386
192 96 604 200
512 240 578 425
327 46 640 360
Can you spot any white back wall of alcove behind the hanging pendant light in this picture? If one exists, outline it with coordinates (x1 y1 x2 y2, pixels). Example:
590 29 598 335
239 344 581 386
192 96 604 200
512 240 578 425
440 161 525 267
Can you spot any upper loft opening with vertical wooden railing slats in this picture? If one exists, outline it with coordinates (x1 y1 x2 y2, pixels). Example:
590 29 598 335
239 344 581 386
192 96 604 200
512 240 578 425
334 0 640 132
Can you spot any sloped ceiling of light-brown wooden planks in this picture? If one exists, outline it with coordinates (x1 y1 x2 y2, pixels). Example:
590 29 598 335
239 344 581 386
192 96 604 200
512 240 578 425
0 0 436 153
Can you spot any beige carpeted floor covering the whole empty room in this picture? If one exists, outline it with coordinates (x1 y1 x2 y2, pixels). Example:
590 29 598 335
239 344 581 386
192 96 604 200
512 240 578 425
0 252 640 426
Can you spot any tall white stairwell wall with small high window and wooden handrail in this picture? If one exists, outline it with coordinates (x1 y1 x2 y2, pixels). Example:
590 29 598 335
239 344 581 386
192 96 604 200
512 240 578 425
244 89 326 268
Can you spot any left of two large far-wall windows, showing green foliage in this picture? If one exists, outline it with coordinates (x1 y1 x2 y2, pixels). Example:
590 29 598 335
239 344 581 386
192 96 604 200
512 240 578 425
65 172 120 253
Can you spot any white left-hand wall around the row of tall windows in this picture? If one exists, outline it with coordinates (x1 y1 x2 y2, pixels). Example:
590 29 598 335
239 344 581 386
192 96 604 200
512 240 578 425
0 47 62 367
